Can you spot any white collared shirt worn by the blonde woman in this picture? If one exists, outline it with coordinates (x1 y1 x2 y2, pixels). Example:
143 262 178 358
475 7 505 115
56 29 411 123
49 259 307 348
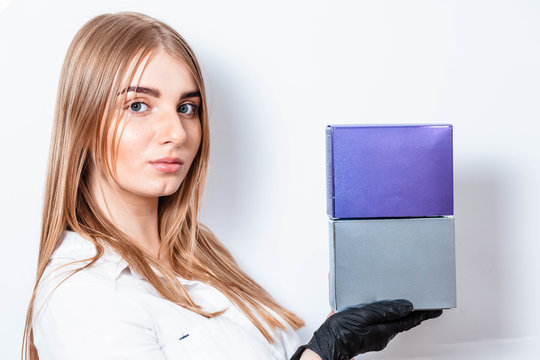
33 231 299 360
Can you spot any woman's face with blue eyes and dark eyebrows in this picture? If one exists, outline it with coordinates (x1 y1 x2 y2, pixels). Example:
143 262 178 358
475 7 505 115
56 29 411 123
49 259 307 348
101 51 202 197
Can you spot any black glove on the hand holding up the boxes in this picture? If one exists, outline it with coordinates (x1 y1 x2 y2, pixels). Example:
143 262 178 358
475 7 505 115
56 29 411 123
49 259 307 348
291 300 442 360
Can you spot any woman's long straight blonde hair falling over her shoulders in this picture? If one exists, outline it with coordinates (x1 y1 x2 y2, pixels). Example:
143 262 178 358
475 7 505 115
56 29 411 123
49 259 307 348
21 12 304 360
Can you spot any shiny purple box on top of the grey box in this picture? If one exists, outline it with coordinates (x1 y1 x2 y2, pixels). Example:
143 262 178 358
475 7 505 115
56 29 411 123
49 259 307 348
326 124 454 219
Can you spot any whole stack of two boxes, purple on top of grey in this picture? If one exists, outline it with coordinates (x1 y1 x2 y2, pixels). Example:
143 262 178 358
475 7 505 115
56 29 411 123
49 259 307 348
326 125 456 310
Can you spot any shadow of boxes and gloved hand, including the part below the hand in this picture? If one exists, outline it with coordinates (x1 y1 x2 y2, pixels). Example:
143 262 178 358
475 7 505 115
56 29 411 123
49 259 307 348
364 164 511 359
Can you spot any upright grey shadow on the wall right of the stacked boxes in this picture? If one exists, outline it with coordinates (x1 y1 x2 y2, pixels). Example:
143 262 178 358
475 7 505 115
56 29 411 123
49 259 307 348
444 165 511 342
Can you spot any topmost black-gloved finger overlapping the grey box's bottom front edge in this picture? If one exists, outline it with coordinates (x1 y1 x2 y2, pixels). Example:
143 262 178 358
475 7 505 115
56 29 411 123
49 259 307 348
344 299 413 326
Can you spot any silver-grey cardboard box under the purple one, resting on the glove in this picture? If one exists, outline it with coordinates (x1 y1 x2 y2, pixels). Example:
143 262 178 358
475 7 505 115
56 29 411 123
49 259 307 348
329 217 456 310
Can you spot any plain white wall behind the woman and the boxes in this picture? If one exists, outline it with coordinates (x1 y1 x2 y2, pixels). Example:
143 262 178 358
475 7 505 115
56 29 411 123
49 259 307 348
0 0 540 359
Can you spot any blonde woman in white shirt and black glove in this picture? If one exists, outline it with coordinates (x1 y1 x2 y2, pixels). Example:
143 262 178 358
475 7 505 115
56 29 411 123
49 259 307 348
22 12 439 360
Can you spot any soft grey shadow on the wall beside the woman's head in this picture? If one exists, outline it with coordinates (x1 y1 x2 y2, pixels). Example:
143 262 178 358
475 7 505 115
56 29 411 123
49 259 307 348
195 49 263 250
